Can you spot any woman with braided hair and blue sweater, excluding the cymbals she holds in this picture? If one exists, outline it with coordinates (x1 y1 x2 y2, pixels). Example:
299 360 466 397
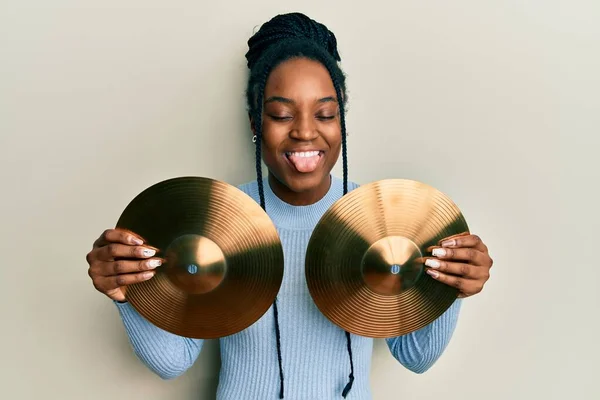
87 13 492 400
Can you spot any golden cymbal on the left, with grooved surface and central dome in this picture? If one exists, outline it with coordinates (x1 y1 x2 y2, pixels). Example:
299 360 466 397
117 177 283 339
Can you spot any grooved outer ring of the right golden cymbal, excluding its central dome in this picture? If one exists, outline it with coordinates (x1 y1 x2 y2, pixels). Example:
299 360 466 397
305 179 468 338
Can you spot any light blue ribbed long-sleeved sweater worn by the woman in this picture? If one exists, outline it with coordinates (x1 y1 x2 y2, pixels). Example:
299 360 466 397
116 177 461 400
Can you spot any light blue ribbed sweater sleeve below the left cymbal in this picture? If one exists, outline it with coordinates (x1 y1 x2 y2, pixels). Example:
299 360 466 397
115 302 203 379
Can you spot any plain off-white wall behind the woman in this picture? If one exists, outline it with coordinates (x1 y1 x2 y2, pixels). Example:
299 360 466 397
0 0 600 400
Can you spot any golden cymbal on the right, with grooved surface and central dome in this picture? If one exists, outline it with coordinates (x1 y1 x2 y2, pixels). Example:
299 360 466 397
306 179 468 338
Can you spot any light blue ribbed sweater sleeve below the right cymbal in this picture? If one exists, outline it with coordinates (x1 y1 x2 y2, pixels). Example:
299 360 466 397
386 299 462 374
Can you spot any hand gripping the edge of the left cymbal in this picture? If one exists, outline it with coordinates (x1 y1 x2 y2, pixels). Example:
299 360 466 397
85 229 163 302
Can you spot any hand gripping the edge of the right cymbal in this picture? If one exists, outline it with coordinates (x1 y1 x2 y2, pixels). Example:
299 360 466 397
425 233 494 297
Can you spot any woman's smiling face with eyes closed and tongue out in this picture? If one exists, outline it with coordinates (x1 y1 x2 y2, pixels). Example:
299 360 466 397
262 58 342 193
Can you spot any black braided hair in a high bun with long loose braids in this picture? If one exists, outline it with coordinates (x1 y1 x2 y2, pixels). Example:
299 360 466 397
246 13 354 399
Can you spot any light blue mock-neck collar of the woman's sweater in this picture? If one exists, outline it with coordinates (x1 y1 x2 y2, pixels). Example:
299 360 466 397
263 175 344 229
